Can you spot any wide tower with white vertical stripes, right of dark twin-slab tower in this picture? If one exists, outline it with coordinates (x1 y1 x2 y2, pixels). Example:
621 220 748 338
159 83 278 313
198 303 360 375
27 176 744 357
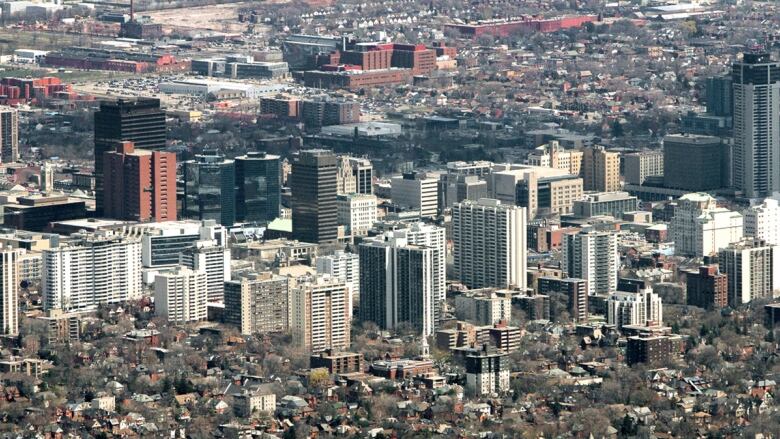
452 198 526 289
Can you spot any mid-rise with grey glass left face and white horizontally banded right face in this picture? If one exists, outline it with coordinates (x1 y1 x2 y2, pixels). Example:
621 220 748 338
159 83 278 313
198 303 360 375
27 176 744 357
390 172 439 218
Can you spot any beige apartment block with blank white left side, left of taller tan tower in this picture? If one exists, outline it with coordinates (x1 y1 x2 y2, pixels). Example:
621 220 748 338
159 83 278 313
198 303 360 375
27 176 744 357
225 272 290 335
